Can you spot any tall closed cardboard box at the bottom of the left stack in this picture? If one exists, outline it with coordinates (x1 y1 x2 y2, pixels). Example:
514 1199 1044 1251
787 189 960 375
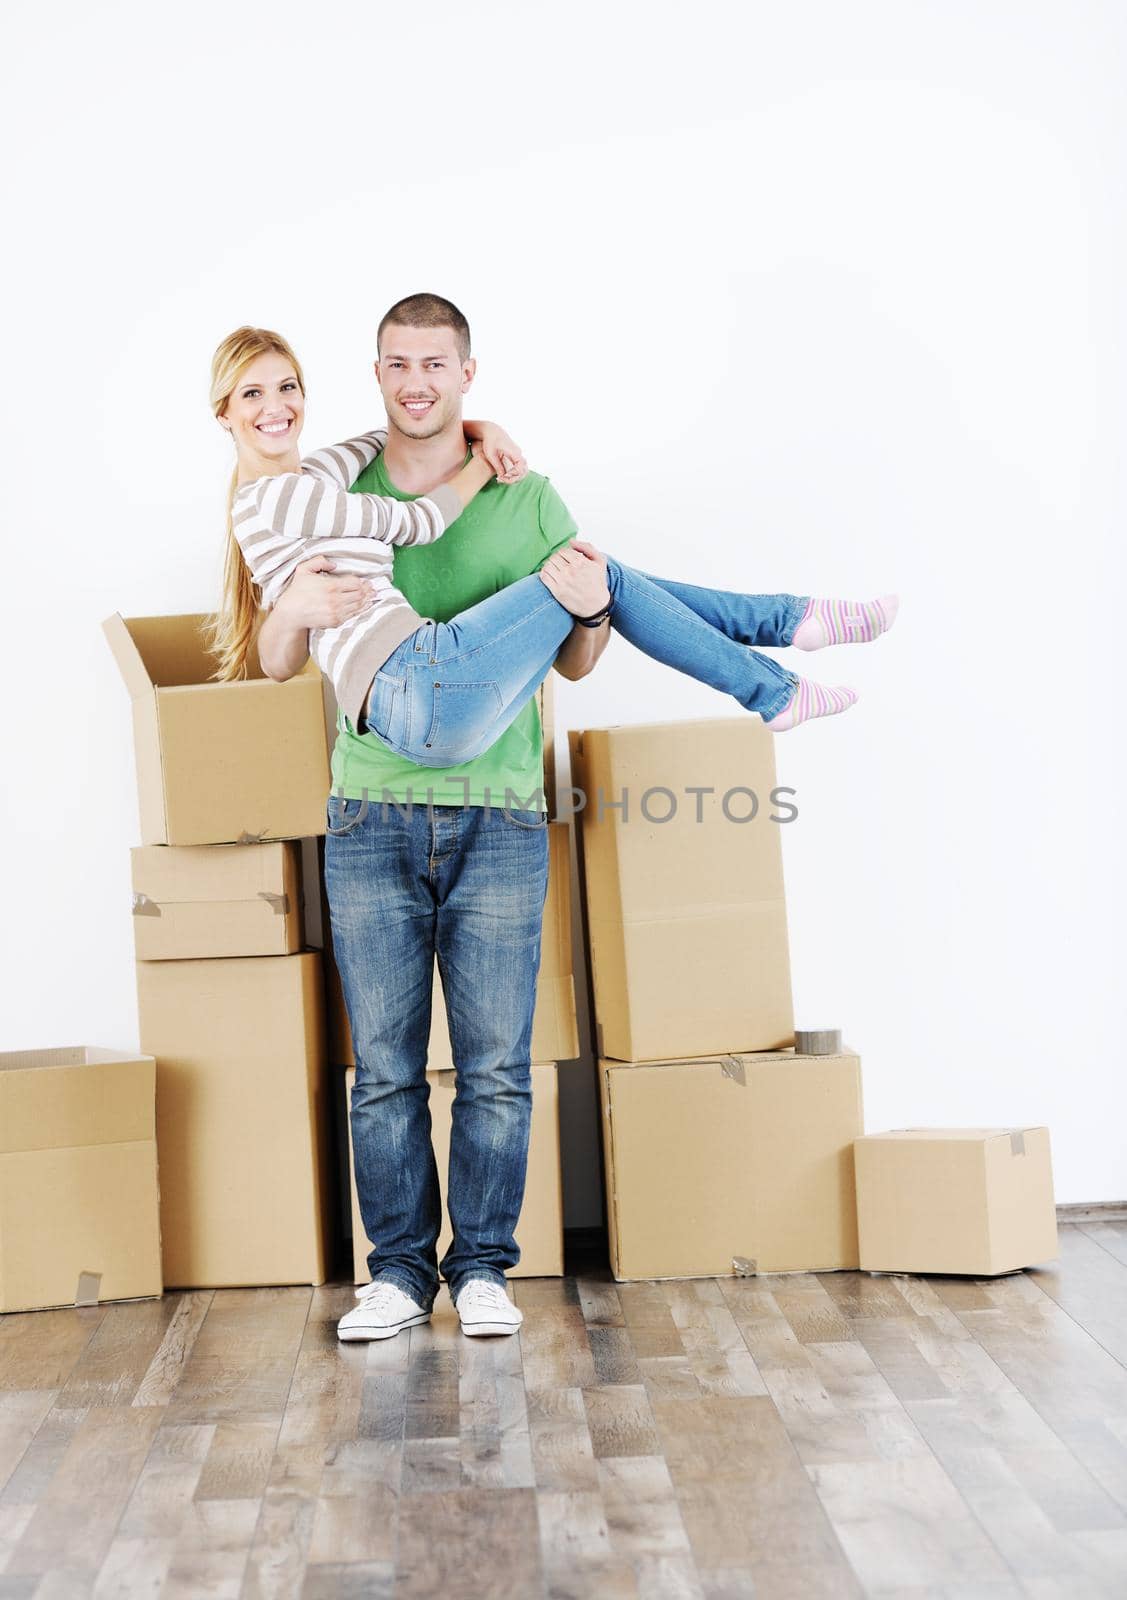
136 950 335 1288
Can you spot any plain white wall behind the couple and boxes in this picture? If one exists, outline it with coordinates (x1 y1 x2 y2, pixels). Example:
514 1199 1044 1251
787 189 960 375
0 0 1127 1222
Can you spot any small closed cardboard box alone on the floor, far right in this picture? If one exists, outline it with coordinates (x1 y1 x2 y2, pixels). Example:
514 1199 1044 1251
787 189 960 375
853 1128 1060 1277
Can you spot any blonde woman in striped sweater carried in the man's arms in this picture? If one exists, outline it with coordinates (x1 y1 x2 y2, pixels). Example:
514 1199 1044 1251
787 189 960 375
211 328 898 766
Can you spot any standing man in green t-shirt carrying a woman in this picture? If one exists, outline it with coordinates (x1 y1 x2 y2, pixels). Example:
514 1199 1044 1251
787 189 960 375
259 294 610 1339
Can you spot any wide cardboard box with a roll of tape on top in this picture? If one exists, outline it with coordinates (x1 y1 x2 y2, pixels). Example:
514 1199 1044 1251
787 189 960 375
599 1050 864 1280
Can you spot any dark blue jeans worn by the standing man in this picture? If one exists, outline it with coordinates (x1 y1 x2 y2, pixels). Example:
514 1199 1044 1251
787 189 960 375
325 800 555 1310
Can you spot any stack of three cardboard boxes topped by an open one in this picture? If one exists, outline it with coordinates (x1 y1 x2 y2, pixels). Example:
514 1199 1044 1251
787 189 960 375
104 616 333 1288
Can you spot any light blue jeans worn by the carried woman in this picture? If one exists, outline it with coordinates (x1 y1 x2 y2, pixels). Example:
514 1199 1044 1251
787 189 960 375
362 557 807 766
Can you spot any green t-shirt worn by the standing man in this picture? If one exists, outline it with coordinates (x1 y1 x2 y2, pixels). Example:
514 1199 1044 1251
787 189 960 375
333 456 578 806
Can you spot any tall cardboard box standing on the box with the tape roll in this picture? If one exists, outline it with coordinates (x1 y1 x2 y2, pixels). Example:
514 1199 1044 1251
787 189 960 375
570 717 794 1061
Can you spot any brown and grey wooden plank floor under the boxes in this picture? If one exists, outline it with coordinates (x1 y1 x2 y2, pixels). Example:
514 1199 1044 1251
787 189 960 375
0 1224 1127 1600
